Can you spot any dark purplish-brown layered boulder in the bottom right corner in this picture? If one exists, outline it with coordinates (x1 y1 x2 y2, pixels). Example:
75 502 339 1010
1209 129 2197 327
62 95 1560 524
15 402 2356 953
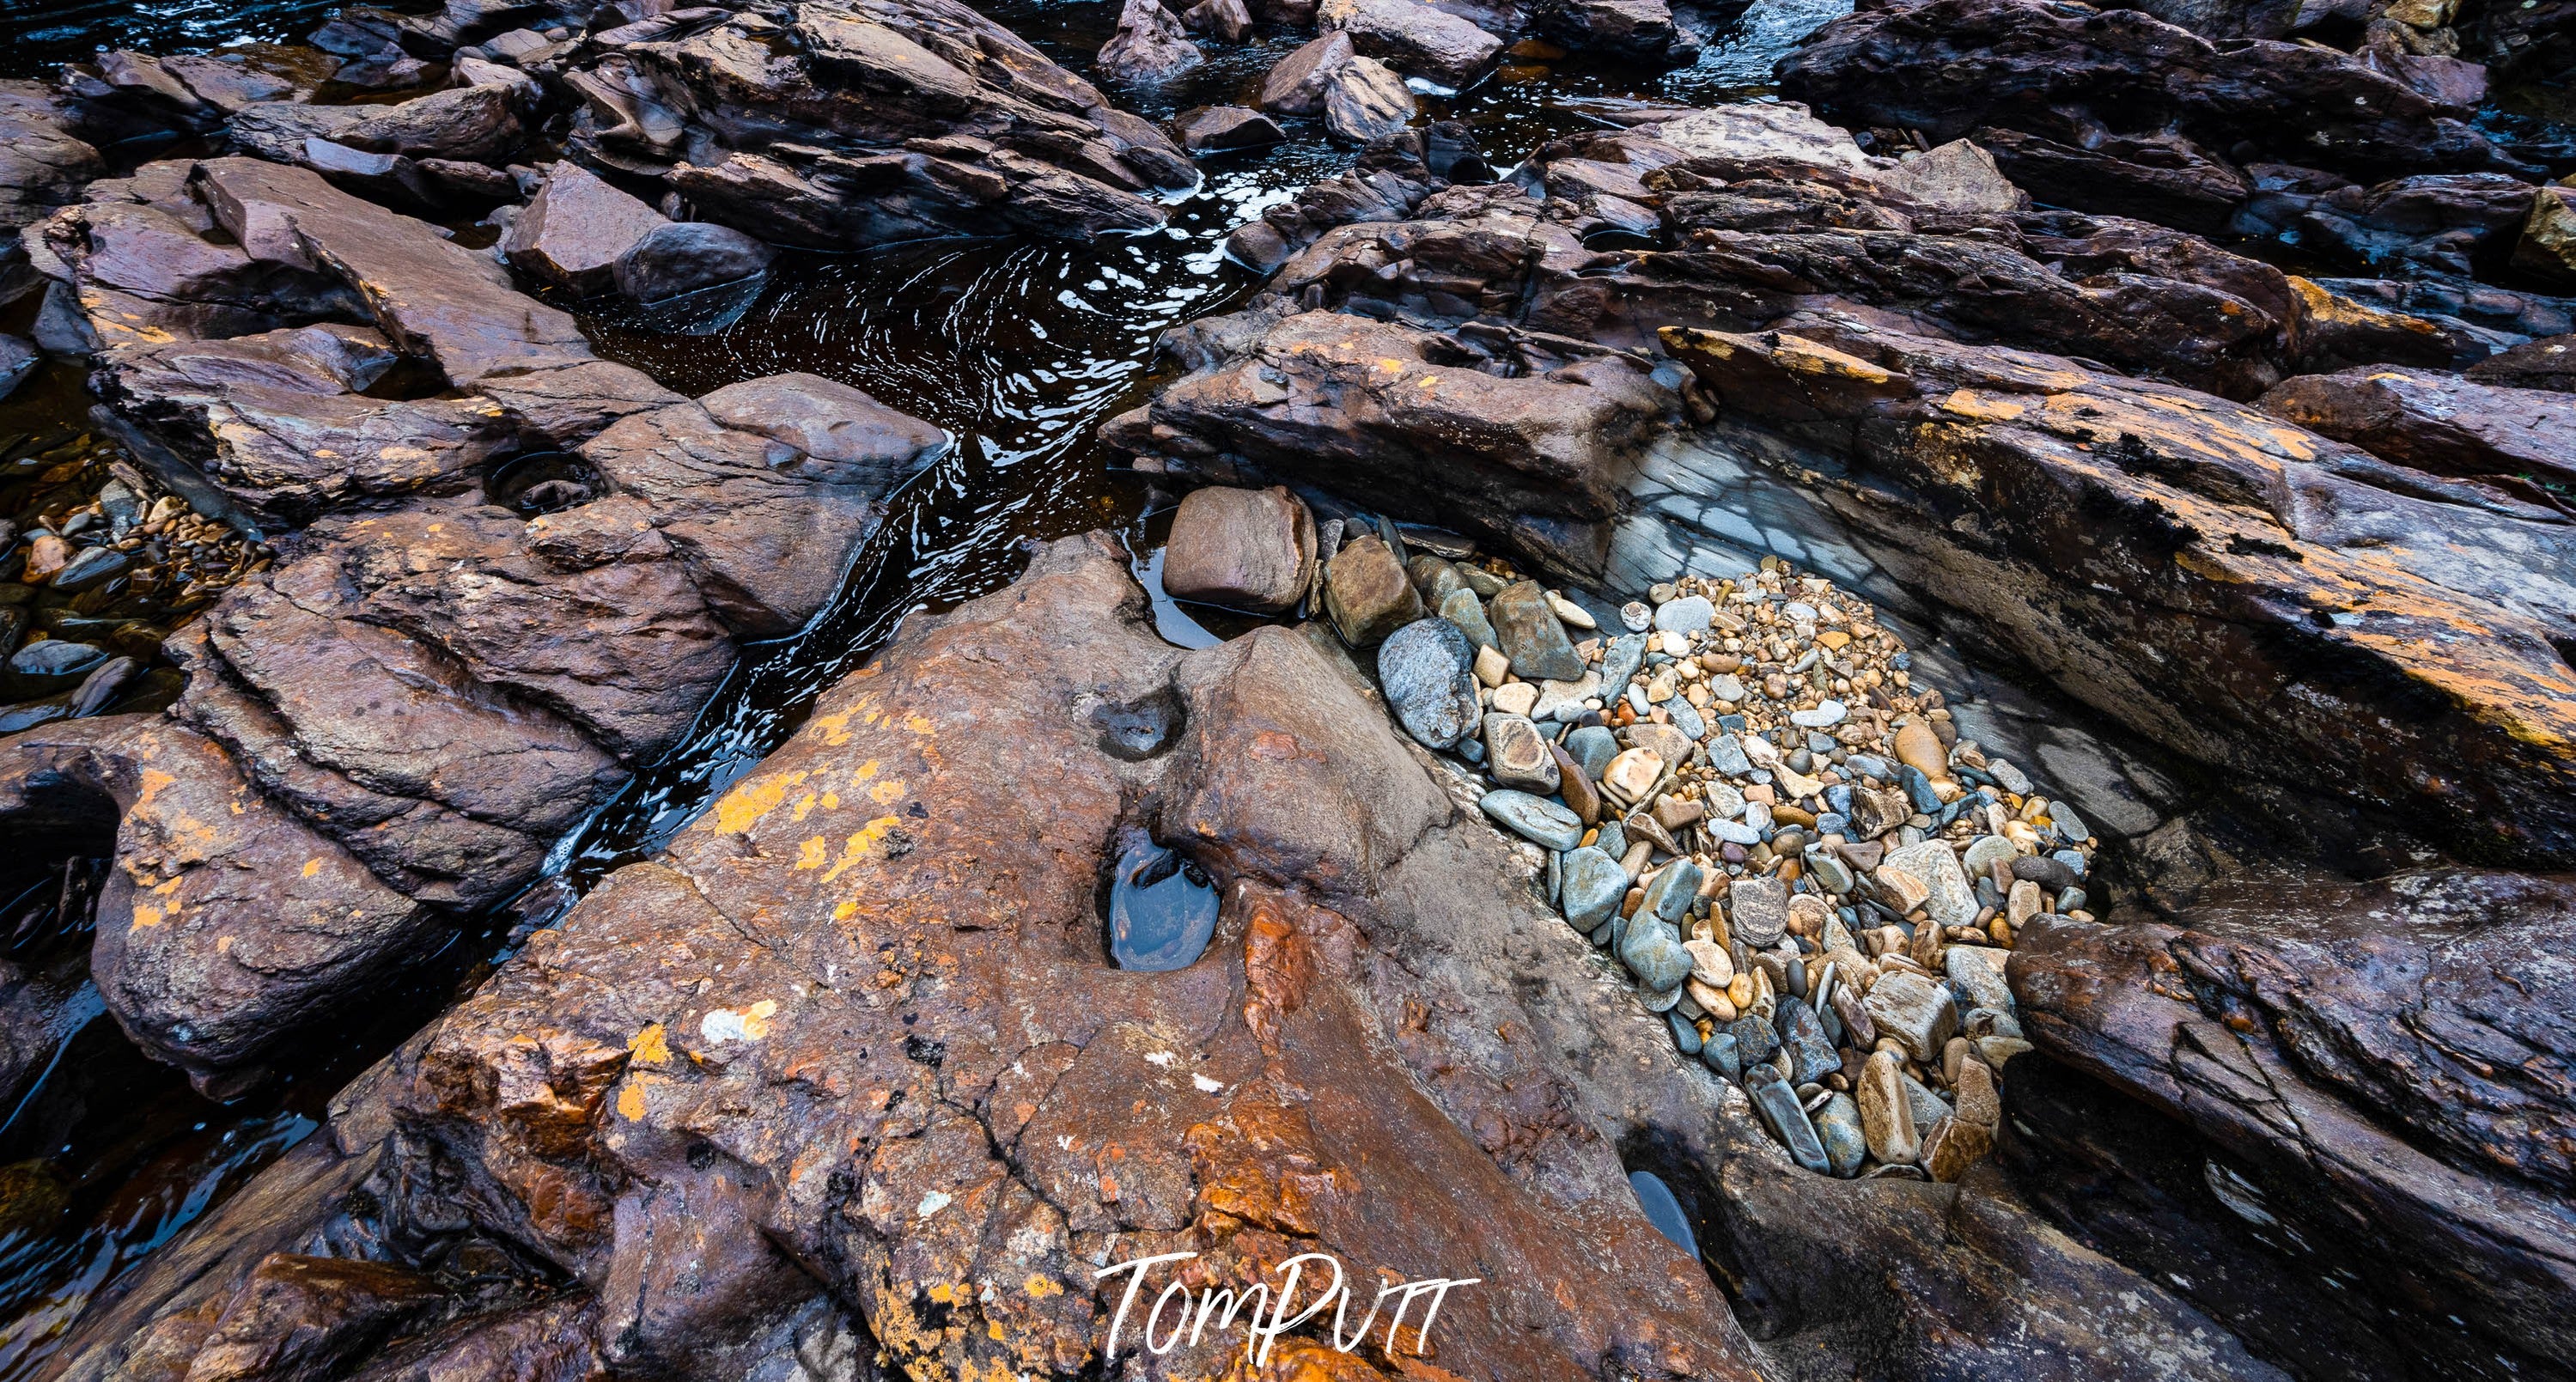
2009 873 2576 1377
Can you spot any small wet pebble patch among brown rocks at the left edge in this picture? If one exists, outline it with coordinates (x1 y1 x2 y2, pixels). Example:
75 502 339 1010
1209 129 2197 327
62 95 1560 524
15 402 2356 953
0 432 273 734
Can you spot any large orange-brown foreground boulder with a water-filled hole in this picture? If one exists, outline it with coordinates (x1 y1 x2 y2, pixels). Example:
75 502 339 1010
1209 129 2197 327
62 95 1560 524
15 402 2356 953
50 535 2277 1382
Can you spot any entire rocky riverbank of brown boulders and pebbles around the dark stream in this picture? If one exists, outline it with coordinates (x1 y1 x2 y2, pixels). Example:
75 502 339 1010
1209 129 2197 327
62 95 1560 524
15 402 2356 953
0 0 2576 1379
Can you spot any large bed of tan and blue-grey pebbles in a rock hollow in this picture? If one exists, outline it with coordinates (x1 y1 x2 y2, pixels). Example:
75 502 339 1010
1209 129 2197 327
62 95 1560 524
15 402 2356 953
1349 538 2094 1181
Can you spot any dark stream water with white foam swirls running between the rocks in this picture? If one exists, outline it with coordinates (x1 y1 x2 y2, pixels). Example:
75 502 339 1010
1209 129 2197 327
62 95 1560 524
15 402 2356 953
0 0 1849 1382
